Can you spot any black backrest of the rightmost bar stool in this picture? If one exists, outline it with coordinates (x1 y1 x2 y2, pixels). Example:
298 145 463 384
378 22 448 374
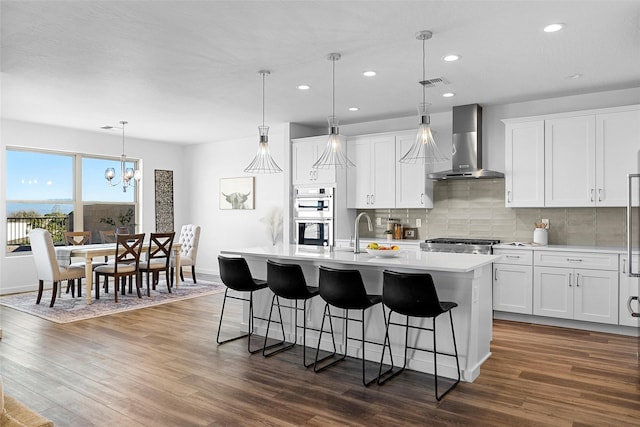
382 270 444 317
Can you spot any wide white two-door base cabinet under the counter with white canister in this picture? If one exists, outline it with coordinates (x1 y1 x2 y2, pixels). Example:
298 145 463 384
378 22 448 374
533 251 619 324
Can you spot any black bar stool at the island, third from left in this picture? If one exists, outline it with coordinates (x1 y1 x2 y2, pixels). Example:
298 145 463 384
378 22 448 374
313 266 391 386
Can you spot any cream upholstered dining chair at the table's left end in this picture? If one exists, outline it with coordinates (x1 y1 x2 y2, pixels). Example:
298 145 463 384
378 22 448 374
29 228 85 307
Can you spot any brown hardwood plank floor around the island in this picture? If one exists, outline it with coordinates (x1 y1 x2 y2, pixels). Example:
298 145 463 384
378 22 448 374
0 294 640 427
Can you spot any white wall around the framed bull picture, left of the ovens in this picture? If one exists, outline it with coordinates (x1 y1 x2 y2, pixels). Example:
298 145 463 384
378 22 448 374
185 125 291 274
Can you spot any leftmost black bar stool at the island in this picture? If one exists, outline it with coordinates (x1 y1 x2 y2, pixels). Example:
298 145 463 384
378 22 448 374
216 255 276 354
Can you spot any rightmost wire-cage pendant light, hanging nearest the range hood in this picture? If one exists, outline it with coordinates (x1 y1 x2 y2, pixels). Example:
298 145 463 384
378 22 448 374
399 31 449 166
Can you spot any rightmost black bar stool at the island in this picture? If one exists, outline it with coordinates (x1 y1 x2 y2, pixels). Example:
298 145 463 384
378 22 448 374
378 270 460 401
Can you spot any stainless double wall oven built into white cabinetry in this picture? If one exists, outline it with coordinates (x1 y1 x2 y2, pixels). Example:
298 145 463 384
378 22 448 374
293 187 335 246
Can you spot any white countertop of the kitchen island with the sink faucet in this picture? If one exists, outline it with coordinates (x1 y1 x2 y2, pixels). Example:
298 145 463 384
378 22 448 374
220 245 500 273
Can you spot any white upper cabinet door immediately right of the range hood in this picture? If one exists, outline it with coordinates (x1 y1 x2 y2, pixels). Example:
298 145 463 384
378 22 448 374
505 120 544 208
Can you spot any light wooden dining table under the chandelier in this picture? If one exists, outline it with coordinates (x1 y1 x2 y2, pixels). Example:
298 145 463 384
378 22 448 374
55 242 182 304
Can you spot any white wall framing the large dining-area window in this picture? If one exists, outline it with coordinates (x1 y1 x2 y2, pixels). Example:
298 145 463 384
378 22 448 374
0 119 191 294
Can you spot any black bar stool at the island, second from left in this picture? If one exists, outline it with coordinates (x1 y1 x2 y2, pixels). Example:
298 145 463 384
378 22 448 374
262 260 328 368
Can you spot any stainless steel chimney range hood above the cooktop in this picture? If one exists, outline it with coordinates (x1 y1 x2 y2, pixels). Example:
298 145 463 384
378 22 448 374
427 104 504 180
